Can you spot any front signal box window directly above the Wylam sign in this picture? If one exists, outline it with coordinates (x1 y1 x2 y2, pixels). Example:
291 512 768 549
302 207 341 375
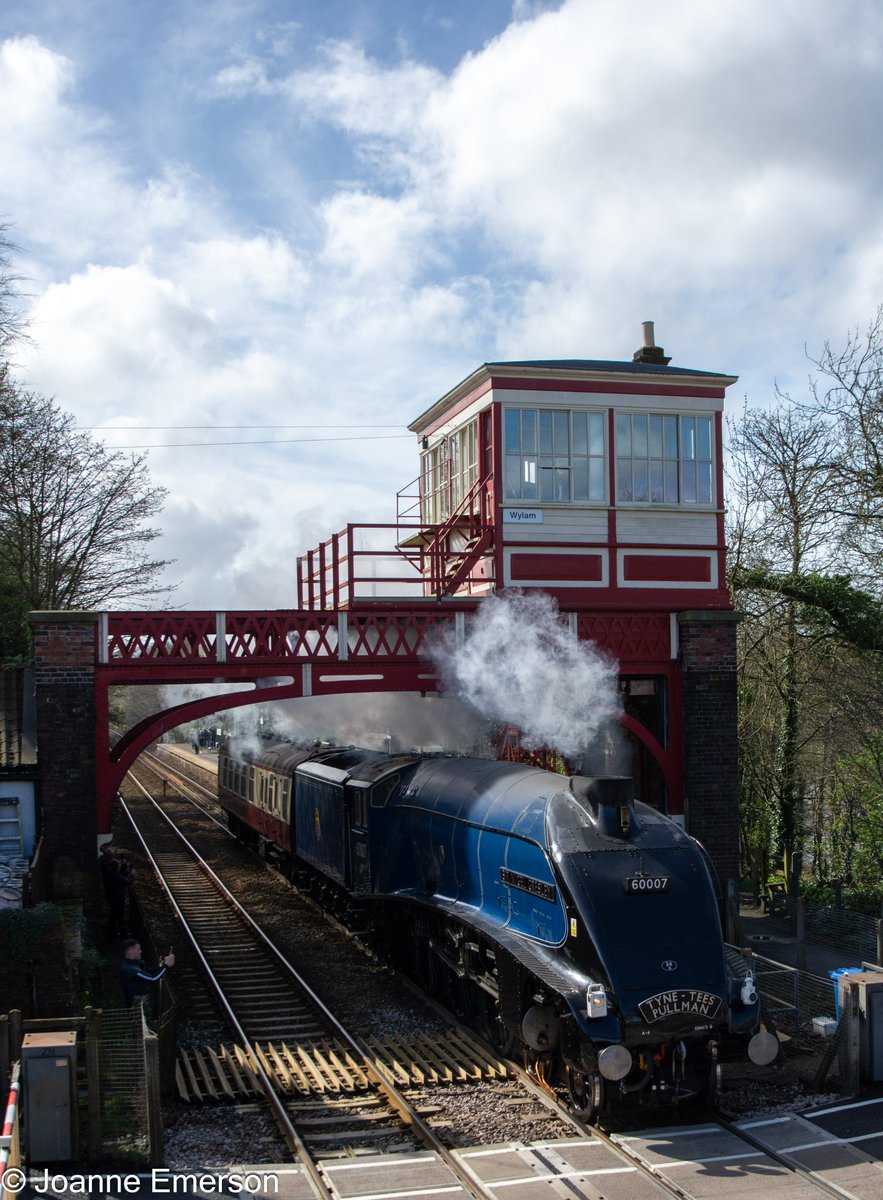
503 408 607 503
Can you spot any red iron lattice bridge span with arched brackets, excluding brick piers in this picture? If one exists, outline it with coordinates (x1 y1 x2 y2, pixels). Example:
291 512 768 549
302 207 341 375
91 601 680 829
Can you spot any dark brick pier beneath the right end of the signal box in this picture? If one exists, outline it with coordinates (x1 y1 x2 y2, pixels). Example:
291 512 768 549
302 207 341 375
678 612 739 889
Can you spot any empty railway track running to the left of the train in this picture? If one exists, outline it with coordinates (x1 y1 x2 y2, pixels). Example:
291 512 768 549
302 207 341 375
121 768 527 1198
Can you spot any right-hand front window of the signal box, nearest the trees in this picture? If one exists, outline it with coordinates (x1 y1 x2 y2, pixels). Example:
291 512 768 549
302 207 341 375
617 413 714 504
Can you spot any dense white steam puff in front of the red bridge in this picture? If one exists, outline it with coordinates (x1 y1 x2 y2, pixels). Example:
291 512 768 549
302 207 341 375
433 592 621 758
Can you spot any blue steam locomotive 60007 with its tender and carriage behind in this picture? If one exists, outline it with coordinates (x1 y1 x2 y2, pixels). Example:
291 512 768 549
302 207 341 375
218 743 777 1120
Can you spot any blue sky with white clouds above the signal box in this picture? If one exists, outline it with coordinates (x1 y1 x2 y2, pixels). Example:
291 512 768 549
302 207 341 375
0 0 883 610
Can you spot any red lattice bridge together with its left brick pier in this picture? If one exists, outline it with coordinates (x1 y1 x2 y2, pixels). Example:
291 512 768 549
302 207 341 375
29 599 729 902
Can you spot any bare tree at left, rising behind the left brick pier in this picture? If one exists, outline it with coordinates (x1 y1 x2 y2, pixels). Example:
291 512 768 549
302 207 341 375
0 366 176 662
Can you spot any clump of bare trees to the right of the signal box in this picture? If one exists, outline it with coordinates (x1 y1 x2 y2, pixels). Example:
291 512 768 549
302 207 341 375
728 307 883 902
